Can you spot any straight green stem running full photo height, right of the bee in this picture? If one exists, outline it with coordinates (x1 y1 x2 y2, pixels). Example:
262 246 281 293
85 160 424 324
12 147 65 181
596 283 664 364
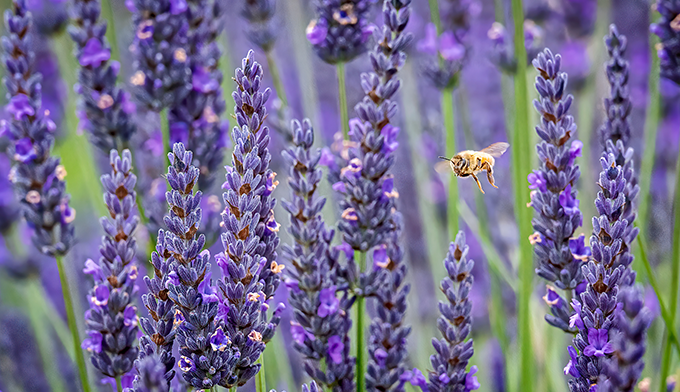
512 0 534 392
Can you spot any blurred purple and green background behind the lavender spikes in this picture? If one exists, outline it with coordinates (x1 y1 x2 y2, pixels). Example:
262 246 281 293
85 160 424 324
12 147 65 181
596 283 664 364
0 0 680 392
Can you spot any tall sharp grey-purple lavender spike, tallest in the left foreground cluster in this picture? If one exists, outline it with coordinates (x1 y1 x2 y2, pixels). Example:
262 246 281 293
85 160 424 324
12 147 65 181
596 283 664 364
215 50 284 388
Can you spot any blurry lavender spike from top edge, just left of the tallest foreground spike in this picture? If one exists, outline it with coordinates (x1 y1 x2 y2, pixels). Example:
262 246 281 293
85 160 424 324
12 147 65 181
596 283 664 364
168 0 226 192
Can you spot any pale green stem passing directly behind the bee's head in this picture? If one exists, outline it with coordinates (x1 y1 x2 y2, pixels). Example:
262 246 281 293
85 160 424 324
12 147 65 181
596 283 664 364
442 88 458 241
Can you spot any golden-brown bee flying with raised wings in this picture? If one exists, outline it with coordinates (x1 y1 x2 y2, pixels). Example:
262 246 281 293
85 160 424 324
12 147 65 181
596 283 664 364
438 142 510 193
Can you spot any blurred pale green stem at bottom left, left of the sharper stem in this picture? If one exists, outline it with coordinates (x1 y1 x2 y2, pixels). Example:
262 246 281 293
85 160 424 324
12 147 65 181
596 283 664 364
23 278 65 392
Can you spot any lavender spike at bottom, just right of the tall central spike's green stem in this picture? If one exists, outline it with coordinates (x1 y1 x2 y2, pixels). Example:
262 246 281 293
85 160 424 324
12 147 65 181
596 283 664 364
366 212 411 391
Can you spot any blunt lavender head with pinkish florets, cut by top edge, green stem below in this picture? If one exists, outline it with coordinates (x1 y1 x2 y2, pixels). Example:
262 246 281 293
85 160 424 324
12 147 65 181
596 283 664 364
130 0 191 111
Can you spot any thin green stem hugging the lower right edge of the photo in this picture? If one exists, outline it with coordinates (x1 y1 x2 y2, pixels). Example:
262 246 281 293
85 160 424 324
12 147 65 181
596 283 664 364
660 136 680 390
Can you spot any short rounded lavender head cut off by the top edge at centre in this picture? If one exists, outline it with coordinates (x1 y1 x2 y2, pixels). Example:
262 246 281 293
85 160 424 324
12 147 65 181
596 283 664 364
307 0 372 64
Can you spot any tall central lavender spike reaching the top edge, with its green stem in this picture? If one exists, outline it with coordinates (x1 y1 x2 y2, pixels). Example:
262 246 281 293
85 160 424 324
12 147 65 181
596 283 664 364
329 0 412 391
